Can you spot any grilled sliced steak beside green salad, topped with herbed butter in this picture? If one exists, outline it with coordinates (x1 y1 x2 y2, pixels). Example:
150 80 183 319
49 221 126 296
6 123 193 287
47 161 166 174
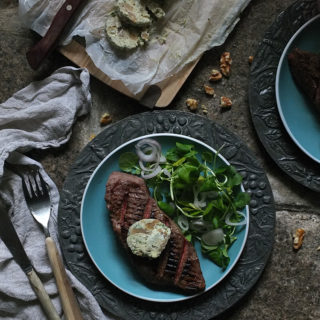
105 172 205 293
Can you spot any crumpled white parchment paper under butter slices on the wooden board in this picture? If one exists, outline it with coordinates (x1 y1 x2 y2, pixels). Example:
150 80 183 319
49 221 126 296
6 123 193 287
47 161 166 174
19 0 250 94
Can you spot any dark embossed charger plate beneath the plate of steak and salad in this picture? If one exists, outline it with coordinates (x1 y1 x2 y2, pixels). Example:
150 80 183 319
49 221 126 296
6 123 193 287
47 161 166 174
58 111 275 320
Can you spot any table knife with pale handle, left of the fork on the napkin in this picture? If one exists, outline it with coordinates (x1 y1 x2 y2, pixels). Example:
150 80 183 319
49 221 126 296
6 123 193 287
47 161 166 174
0 206 60 320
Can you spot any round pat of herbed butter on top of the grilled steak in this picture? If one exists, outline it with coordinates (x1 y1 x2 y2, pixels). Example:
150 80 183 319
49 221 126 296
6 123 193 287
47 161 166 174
127 219 171 259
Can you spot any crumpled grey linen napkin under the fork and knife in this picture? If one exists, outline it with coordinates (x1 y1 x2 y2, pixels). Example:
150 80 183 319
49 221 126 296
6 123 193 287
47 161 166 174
0 67 107 320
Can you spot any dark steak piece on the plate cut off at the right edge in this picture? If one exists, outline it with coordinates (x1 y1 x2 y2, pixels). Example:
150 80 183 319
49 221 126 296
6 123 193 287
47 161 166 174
288 48 320 111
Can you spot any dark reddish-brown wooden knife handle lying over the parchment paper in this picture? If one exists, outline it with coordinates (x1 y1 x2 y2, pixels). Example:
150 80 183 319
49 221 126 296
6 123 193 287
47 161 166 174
27 0 85 70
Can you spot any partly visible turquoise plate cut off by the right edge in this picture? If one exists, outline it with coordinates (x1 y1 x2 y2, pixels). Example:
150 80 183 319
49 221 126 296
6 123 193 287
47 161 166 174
275 15 320 163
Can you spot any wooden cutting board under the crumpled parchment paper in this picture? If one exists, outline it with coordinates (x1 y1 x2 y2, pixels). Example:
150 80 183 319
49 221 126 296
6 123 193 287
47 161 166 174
59 40 200 108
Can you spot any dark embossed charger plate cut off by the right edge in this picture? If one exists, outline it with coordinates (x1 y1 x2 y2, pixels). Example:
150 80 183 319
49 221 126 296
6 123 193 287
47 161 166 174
249 0 320 192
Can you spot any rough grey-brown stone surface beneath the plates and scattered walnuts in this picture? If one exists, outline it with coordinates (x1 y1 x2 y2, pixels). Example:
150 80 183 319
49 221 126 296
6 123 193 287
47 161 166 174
0 0 320 320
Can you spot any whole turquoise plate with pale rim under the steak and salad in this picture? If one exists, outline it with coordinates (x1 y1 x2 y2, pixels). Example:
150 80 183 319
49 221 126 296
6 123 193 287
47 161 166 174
81 133 249 302
